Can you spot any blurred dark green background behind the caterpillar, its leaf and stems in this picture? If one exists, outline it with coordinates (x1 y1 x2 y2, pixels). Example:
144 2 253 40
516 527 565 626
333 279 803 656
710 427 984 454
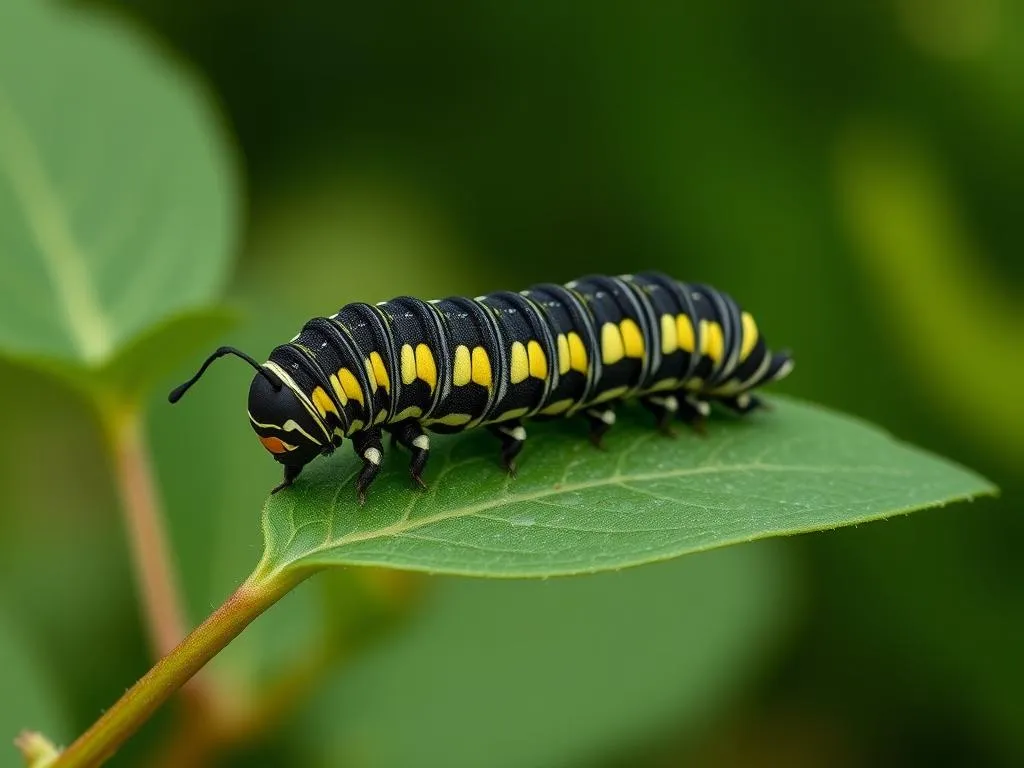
0 0 1024 768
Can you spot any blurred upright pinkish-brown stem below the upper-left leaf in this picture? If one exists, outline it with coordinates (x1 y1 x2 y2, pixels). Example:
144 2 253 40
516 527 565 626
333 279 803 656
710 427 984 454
101 408 187 658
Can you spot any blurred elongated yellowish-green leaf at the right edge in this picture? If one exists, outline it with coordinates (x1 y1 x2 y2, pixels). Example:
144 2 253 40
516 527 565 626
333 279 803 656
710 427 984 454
837 122 1024 462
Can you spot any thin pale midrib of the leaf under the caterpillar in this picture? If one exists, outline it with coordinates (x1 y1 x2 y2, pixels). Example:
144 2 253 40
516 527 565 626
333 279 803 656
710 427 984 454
257 462 912 571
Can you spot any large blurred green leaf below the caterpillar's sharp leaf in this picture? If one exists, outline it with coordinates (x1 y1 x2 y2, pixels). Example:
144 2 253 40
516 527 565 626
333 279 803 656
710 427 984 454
294 542 797 768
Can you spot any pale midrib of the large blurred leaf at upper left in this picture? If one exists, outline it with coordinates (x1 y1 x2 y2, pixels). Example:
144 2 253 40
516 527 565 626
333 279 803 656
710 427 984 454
0 85 114 364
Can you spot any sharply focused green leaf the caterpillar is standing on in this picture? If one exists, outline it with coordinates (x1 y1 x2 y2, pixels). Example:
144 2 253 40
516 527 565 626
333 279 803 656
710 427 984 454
261 399 995 577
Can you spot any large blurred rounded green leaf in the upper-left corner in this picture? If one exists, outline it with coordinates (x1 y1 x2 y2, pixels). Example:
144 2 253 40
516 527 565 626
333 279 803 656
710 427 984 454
0 0 238 369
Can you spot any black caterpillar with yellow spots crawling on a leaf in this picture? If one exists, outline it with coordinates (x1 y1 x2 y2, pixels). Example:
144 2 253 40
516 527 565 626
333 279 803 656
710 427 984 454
169 272 793 503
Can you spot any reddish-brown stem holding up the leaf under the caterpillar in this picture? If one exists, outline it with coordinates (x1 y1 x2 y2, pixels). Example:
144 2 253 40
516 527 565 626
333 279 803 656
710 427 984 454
52 571 311 768
